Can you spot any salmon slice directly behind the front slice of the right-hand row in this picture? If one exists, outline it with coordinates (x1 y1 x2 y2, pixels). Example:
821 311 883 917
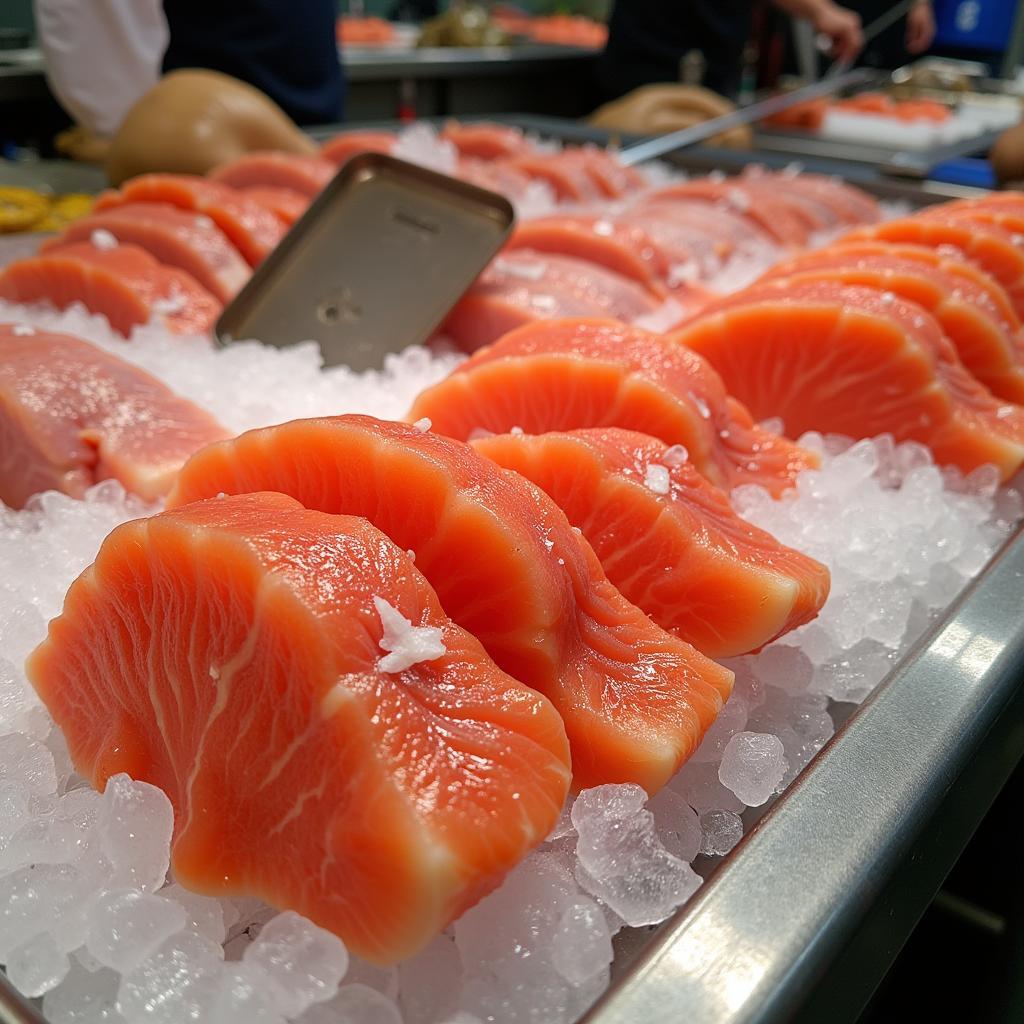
762 246 1024 402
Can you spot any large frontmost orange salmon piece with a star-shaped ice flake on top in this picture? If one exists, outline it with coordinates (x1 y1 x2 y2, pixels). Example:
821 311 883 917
28 494 569 963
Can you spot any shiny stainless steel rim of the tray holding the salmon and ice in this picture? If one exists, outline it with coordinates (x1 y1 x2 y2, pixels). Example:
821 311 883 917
0 116 1024 1024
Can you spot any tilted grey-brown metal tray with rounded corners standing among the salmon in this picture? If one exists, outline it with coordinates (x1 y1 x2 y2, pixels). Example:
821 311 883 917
214 153 515 370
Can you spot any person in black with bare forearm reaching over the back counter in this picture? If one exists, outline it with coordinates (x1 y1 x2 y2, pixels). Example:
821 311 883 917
598 0 863 99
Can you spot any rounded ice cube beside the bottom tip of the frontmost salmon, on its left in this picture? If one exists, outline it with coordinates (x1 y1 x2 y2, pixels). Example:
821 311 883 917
243 910 348 1017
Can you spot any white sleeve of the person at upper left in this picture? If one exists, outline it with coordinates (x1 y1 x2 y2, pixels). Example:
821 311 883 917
35 0 168 138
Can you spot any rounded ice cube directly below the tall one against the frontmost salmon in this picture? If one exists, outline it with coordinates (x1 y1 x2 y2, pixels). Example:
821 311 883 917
85 889 185 974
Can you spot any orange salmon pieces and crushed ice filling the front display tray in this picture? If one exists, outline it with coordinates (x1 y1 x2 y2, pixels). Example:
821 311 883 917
0 119 1024 1024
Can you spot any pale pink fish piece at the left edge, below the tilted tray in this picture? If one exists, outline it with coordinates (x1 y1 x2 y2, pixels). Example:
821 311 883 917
0 324 227 508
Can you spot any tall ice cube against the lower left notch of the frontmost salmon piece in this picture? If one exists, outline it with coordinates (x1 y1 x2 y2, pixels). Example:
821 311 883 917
98 774 174 892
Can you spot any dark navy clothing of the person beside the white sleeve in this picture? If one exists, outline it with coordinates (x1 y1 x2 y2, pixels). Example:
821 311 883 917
163 0 345 125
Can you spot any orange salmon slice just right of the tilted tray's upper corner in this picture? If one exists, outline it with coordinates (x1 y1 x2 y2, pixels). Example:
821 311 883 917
505 214 672 294
